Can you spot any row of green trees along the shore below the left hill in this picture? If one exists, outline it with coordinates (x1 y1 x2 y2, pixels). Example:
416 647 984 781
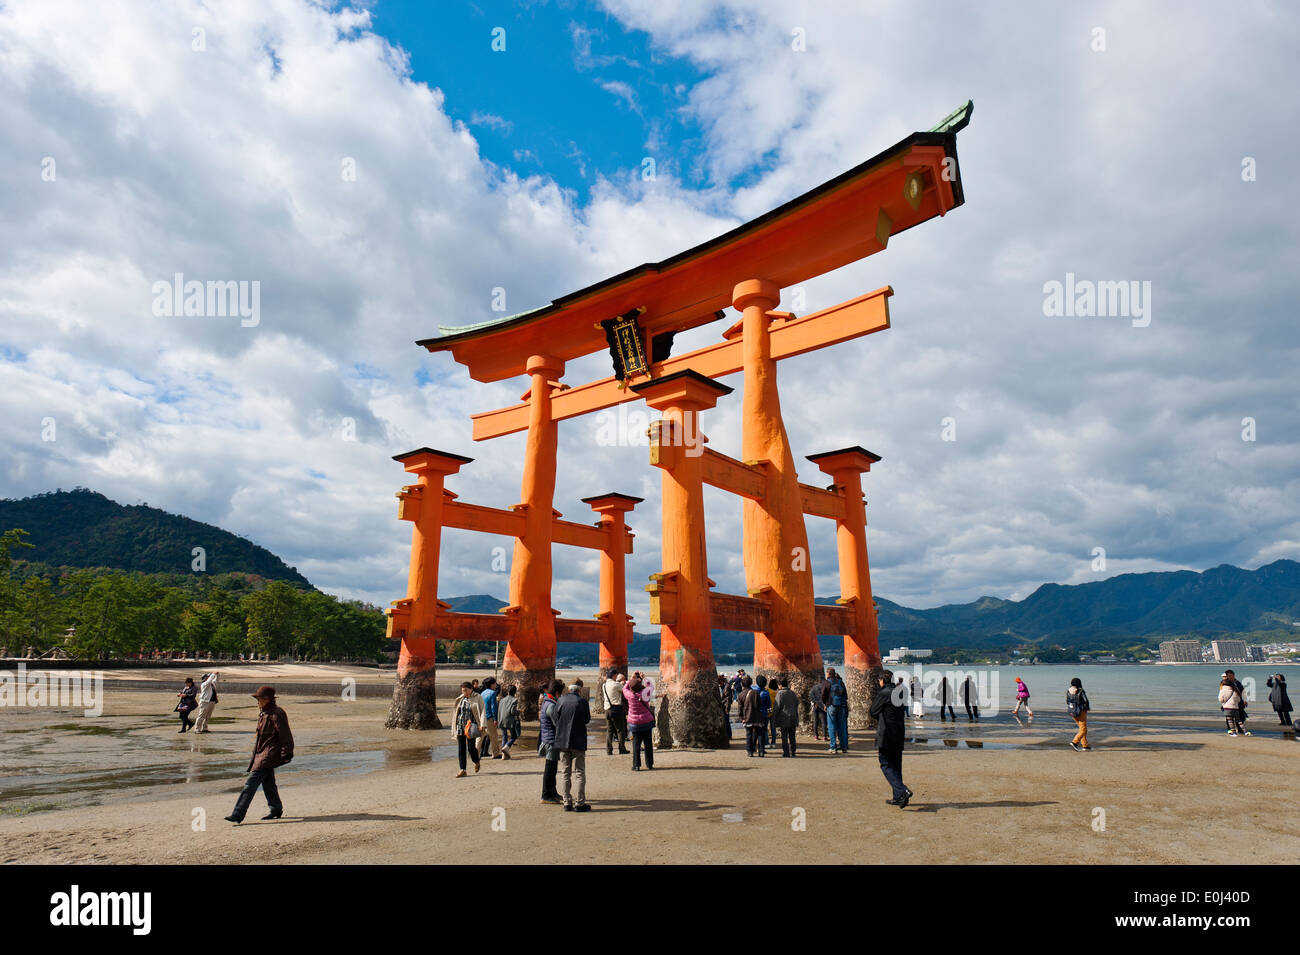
0 529 386 660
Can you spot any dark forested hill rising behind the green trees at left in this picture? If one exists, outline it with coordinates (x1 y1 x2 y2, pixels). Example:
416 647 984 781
0 487 311 586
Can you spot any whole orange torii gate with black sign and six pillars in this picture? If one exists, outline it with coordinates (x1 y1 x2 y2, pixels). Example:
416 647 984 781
387 101 972 747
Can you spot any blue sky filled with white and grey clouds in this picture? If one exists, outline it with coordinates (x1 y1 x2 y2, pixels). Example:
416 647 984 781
0 0 1300 630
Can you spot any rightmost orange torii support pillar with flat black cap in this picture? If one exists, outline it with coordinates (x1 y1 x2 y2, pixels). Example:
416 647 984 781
809 447 880 729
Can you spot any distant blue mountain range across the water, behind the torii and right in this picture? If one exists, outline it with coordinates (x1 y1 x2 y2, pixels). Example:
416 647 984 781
447 560 1300 654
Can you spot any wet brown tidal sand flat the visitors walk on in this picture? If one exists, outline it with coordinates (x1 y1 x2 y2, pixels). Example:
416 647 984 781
0 668 1300 865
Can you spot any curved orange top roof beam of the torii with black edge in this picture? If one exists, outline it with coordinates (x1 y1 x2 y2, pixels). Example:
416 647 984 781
416 101 974 382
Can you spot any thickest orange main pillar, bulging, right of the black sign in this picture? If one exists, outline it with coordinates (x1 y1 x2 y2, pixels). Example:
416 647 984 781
732 279 822 729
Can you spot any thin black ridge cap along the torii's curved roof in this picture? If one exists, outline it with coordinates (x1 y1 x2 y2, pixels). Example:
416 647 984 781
416 123 966 351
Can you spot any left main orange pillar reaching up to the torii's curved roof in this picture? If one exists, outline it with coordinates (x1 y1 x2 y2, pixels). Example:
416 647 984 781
501 355 564 720
